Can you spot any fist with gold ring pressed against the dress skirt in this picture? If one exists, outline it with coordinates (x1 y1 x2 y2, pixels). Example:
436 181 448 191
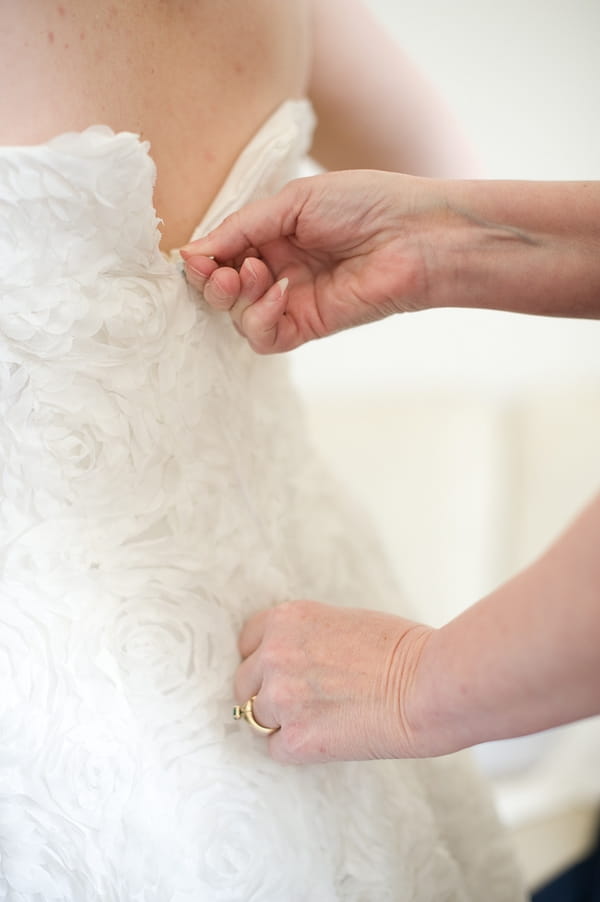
235 601 435 764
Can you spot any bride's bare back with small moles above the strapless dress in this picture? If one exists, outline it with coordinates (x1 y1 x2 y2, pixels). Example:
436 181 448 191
0 0 310 249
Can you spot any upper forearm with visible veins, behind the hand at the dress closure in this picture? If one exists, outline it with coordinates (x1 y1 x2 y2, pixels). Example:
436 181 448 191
423 181 600 318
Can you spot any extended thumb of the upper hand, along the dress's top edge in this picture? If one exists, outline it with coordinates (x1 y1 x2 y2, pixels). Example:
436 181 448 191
180 179 304 262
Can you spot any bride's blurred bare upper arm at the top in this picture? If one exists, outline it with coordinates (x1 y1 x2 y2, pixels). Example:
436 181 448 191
309 0 477 178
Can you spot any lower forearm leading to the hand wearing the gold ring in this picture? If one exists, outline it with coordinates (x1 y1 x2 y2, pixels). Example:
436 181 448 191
409 497 600 754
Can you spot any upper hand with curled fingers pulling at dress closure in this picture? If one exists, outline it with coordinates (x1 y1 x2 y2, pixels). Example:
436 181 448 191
182 171 436 354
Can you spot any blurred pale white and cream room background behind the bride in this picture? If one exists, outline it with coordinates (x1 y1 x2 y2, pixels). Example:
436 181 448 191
292 0 600 888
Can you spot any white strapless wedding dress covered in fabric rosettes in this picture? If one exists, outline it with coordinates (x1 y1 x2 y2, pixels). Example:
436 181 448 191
0 101 522 902
